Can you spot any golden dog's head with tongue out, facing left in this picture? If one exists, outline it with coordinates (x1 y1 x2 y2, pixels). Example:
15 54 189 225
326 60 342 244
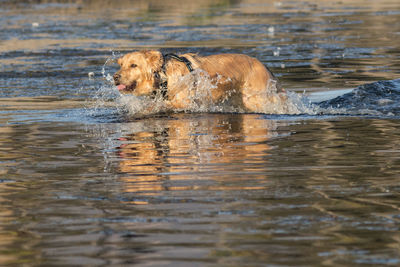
114 50 163 96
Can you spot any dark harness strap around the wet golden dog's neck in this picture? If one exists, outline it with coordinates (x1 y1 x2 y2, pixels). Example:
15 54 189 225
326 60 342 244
153 53 193 99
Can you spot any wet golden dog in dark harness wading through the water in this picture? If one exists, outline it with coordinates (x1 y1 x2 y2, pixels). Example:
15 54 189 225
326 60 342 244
113 50 286 113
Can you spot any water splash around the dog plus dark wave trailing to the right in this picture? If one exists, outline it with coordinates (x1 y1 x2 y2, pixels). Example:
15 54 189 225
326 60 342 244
87 59 400 117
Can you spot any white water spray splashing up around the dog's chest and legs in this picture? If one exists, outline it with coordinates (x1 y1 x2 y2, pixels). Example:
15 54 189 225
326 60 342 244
87 51 318 116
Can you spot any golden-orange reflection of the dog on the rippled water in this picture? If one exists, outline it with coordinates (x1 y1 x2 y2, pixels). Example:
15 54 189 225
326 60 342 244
118 114 276 196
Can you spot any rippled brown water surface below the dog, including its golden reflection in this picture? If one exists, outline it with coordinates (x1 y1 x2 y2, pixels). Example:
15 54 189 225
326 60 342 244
0 114 400 265
